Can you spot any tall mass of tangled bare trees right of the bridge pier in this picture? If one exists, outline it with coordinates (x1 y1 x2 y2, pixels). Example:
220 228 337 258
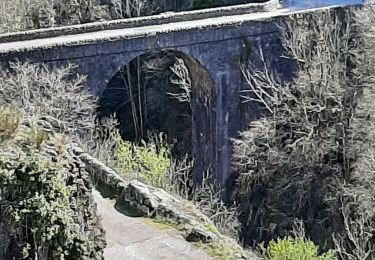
233 7 375 259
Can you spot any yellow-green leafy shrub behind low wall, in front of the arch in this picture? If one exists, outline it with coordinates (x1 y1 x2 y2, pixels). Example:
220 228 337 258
114 134 170 188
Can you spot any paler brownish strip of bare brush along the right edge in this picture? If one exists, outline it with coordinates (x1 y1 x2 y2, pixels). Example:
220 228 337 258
334 6 375 260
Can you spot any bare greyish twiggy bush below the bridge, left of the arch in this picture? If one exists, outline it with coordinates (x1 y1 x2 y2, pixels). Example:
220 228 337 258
0 62 97 140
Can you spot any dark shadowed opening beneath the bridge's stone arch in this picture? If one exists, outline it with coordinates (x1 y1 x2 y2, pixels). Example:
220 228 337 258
99 50 215 182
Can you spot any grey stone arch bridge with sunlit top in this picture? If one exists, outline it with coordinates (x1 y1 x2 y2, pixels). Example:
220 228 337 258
0 0 368 187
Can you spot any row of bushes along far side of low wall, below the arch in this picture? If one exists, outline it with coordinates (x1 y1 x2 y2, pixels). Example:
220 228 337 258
93 118 240 238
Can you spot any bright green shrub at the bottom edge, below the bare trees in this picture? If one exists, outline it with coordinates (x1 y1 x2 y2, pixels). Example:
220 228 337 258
264 236 335 260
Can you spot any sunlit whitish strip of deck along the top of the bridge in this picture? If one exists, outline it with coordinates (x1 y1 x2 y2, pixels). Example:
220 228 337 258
0 7 344 54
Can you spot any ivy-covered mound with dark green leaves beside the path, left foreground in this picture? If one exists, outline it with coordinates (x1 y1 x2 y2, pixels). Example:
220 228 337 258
0 108 105 260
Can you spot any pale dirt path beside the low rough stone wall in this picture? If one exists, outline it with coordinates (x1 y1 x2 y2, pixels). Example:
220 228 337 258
93 190 213 260
